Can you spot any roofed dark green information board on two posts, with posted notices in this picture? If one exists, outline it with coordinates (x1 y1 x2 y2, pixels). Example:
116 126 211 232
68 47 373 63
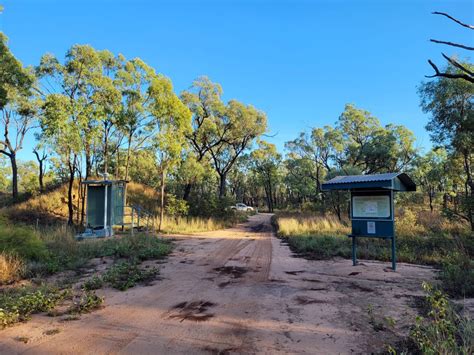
321 173 416 270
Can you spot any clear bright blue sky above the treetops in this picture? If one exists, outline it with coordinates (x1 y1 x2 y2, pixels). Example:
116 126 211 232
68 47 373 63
0 0 474 163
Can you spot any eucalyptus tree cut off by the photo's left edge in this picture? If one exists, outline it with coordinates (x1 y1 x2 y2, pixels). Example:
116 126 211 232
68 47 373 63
0 32 40 198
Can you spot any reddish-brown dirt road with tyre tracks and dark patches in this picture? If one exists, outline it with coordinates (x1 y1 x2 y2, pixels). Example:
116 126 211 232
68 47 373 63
0 214 433 354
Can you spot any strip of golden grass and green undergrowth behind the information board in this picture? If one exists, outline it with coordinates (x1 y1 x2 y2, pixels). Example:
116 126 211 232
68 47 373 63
274 210 474 268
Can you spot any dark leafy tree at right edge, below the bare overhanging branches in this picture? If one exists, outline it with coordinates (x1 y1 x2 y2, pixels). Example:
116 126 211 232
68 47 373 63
419 63 474 230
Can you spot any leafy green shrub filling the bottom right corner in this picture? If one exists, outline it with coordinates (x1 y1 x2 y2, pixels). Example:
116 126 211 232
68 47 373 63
410 283 474 355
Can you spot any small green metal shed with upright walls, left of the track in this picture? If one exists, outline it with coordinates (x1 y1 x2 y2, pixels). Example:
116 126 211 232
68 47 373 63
82 180 127 237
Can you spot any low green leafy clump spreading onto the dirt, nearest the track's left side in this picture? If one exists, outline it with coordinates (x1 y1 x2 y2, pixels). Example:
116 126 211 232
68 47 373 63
103 261 158 291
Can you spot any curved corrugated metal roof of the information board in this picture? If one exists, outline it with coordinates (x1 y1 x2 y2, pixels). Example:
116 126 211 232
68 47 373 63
321 173 416 191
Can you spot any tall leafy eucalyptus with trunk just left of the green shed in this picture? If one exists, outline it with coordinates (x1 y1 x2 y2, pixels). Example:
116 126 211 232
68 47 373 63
37 45 120 224
